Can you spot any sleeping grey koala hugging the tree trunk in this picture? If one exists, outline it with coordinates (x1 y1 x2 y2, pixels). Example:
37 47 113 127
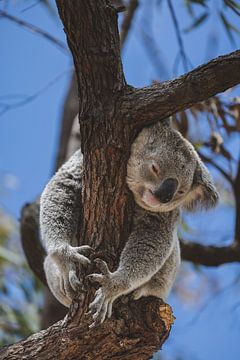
40 120 218 326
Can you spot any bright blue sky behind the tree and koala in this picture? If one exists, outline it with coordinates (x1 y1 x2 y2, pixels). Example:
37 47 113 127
0 0 240 360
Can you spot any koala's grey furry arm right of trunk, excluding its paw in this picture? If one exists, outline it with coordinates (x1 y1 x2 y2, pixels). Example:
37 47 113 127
116 207 177 292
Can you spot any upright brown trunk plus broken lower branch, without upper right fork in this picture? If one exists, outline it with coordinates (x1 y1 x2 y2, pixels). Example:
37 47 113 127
0 0 173 359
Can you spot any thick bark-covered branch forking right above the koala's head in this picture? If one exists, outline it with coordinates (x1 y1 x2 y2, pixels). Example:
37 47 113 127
122 50 240 130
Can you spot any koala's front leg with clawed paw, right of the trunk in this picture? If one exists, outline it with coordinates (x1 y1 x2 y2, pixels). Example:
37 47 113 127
89 211 175 326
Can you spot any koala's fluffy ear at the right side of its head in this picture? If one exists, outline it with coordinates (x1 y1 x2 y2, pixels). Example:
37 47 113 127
184 159 219 211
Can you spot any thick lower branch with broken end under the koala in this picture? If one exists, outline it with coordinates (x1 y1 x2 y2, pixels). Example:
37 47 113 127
0 297 174 360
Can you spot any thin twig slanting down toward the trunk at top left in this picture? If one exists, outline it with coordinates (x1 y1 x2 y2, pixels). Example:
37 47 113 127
0 10 69 54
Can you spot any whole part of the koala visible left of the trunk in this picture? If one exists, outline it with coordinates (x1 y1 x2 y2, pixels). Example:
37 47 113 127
40 150 94 306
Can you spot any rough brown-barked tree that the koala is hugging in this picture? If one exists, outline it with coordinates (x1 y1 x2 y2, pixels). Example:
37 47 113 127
0 0 240 359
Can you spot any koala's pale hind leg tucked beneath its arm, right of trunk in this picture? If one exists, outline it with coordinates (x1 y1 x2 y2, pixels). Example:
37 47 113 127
133 240 181 301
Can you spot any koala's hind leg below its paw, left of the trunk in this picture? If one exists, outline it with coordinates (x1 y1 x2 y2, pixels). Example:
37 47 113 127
44 255 78 307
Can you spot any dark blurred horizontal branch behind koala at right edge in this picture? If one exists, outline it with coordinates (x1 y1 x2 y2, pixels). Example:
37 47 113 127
180 240 240 266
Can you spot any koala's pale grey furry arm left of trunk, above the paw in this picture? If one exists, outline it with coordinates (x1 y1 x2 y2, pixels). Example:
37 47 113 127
40 150 82 253
